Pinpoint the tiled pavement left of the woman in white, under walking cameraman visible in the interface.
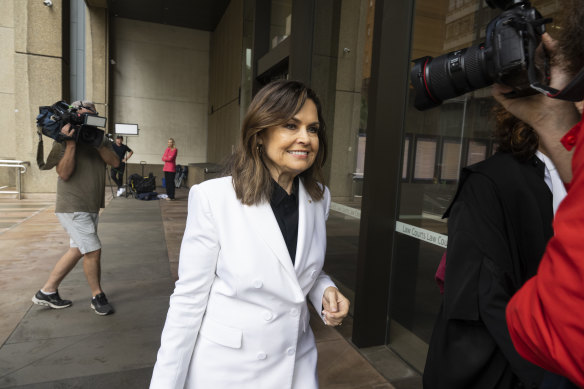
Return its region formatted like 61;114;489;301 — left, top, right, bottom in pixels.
0;192;172;389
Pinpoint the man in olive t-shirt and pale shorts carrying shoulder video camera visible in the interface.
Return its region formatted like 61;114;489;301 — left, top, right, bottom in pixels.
32;101;120;315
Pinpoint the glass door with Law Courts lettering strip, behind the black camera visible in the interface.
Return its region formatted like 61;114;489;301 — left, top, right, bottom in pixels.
387;0;559;371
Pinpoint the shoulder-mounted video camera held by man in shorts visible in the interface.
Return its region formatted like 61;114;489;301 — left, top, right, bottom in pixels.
36;101;107;147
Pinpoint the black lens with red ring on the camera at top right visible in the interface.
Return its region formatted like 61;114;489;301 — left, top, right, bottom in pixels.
411;45;494;111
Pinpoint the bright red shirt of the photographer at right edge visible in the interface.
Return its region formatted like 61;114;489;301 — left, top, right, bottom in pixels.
506;111;584;387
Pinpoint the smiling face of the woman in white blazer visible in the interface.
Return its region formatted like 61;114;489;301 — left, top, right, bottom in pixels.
260;99;319;182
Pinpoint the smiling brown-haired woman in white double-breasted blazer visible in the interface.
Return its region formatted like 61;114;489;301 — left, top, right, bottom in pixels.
150;80;349;389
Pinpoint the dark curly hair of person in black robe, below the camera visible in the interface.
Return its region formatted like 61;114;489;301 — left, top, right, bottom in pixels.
493;104;539;162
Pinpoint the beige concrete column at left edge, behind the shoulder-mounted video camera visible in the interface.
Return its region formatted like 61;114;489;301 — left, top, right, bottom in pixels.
9;0;69;193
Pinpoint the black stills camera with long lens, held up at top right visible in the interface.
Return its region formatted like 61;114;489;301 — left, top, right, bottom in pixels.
411;0;551;111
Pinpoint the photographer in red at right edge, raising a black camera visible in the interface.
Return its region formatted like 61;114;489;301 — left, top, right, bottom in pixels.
494;0;584;388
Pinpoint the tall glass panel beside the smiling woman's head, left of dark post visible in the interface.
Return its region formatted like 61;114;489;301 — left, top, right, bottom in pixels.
322;0;375;310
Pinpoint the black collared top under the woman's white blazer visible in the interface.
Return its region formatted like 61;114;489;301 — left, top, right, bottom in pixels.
270;177;298;263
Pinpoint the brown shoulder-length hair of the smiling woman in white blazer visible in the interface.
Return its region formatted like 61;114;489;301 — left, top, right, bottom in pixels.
225;80;327;205
